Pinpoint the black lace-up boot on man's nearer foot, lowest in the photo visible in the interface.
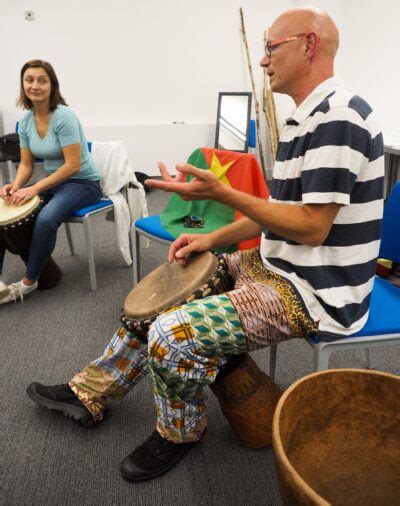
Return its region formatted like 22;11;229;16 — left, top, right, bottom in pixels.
120;430;200;481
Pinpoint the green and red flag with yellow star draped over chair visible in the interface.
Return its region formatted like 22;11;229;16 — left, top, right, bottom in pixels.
160;148;268;252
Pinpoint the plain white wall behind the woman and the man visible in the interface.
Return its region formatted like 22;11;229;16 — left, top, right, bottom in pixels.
0;0;400;173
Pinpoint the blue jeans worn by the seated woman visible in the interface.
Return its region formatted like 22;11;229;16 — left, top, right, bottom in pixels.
23;179;102;281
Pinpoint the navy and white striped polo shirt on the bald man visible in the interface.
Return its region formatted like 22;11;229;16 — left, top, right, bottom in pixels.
261;78;384;334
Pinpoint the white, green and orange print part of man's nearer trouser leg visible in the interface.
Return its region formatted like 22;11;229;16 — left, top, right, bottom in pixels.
149;295;246;443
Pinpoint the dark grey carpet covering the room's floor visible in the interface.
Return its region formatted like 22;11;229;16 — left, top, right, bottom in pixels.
0;191;400;506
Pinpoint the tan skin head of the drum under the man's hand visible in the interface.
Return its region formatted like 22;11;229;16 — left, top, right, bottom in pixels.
124;251;218;319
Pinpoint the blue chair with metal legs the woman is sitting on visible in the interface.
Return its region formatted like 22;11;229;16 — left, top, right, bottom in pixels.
64;141;114;292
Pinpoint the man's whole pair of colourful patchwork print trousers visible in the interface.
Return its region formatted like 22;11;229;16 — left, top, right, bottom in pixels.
69;250;315;443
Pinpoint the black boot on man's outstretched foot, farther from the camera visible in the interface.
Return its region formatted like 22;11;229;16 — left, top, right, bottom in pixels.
26;383;96;428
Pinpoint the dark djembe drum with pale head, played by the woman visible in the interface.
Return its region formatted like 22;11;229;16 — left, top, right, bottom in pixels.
0;196;63;290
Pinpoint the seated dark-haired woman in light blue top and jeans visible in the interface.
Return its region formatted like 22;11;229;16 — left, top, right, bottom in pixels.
0;60;101;304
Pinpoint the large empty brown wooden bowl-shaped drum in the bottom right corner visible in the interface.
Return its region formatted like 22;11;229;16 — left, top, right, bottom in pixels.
273;369;400;506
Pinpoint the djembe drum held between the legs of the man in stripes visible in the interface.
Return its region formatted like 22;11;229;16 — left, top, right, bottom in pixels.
121;252;281;448
